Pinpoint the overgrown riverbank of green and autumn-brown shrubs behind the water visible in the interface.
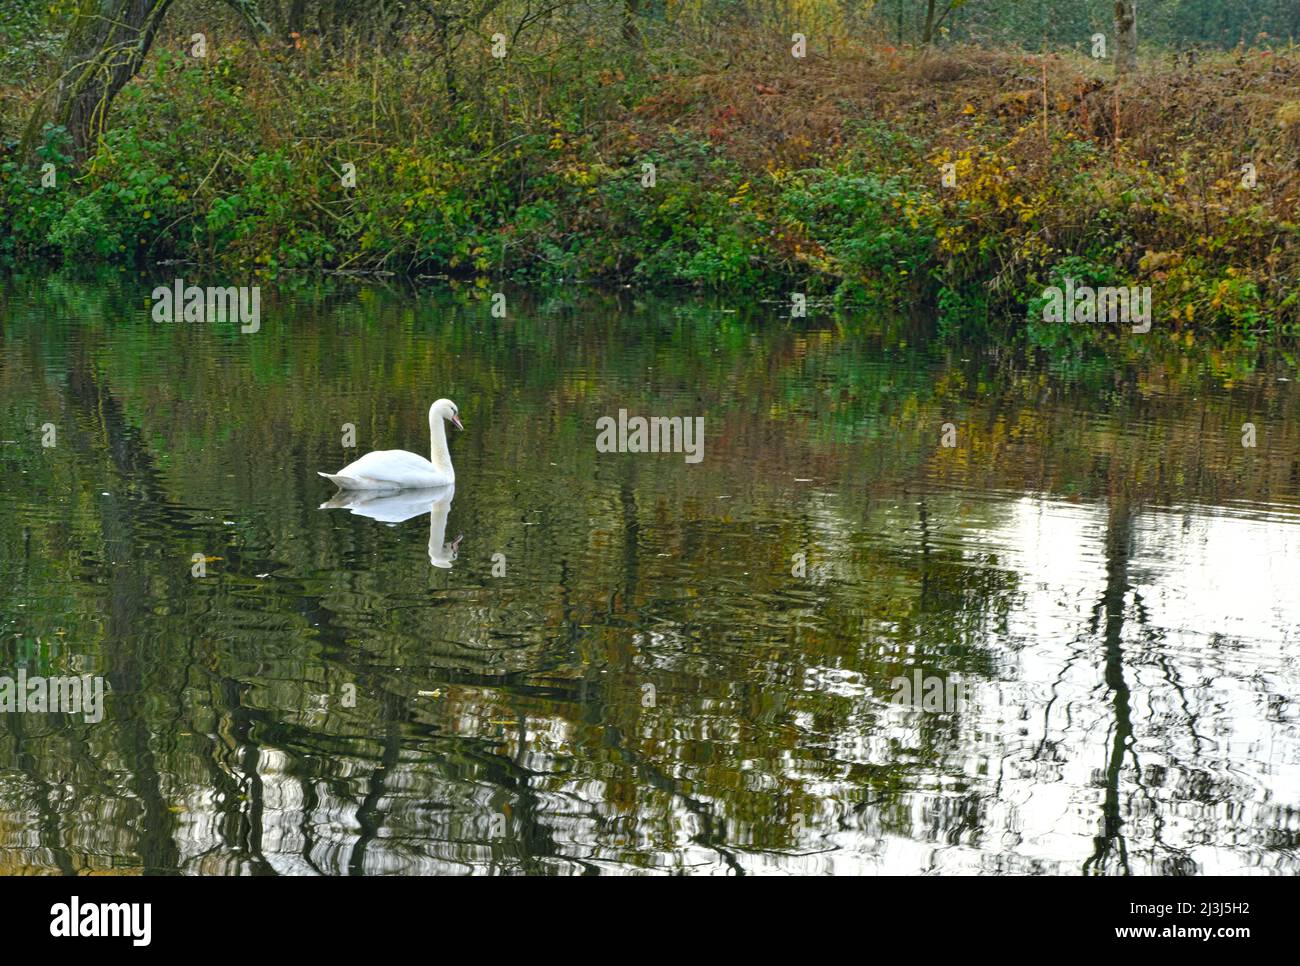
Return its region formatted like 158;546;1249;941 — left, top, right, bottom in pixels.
0;23;1300;341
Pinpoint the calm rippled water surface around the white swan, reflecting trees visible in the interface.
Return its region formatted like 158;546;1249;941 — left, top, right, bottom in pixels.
0;278;1300;875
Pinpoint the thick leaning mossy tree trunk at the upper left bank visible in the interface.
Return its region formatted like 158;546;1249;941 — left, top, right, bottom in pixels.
55;0;173;160
